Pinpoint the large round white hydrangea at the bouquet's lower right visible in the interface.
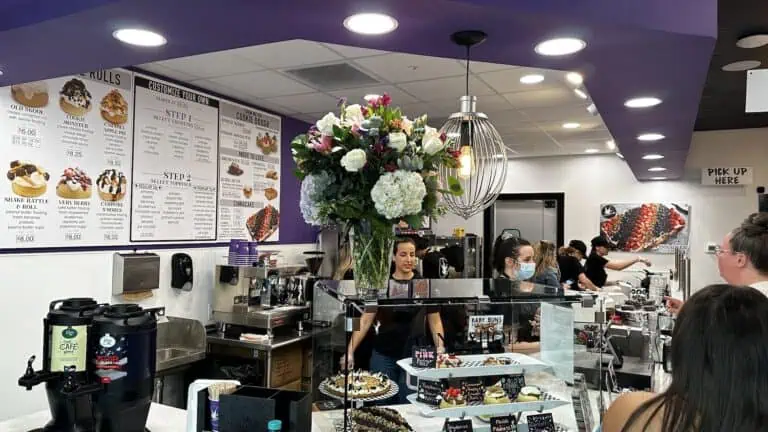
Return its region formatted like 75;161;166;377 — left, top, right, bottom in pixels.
371;170;427;219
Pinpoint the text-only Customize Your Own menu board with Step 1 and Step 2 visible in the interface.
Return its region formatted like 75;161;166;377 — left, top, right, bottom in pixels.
131;75;219;242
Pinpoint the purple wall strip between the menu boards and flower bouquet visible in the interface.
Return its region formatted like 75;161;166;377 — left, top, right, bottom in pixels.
278;116;317;244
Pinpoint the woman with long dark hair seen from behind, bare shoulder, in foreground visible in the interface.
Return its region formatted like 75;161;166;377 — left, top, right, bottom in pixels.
603;285;768;432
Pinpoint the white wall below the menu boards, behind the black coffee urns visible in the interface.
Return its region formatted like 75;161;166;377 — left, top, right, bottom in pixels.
0;245;314;421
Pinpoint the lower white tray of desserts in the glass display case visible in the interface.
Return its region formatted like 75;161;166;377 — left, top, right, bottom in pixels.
408;393;570;418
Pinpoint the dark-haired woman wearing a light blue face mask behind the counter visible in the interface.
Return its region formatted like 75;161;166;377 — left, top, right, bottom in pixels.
493;237;541;352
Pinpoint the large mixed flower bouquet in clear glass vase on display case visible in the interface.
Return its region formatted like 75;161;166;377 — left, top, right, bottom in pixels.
291;94;462;289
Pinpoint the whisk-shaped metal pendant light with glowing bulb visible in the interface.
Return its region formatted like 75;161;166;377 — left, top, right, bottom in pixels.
440;30;507;219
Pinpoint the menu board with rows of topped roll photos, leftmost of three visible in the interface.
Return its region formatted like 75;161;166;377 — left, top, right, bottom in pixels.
0;69;133;249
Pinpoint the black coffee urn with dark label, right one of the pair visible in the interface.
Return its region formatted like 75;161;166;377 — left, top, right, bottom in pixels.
90;304;165;432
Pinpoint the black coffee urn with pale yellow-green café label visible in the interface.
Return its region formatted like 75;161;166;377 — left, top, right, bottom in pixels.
19;298;104;432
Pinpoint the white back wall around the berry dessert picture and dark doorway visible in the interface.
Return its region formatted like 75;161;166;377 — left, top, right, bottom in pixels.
435;128;768;290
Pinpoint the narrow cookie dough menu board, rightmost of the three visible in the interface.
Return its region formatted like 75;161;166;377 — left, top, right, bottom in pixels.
218;101;281;242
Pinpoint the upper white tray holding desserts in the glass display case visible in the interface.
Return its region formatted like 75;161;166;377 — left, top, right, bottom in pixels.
397;353;551;380
